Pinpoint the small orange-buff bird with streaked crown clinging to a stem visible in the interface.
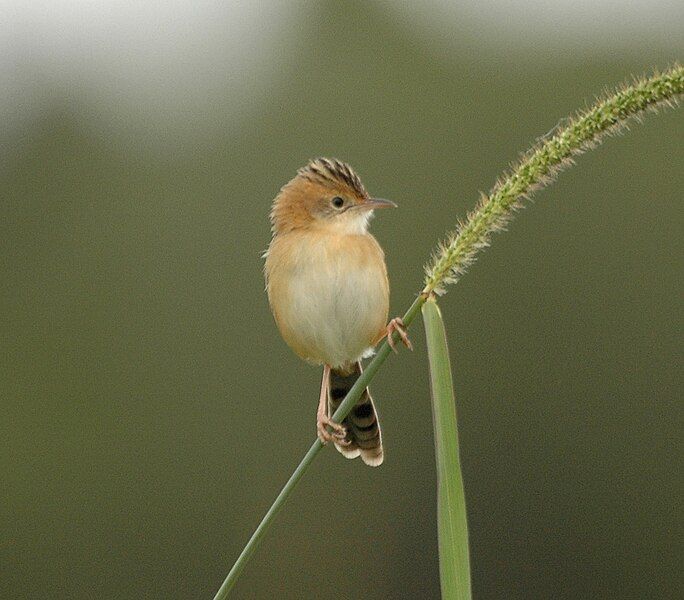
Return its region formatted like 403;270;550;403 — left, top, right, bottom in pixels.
264;158;412;467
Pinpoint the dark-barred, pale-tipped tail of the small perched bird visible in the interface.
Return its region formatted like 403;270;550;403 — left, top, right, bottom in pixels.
328;362;383;467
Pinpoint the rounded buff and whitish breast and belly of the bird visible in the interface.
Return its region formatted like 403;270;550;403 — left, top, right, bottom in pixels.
267;235;388;367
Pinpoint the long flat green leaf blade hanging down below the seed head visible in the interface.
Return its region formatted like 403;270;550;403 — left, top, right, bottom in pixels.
422;297;471;600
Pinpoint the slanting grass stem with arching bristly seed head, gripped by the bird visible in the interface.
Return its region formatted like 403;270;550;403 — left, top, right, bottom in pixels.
214;65;684;600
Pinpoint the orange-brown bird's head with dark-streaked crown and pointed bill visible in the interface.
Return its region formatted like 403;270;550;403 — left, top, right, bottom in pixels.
271;158;396;234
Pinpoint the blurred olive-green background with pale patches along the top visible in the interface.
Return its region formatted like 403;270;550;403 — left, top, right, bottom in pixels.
0;0;684;600
